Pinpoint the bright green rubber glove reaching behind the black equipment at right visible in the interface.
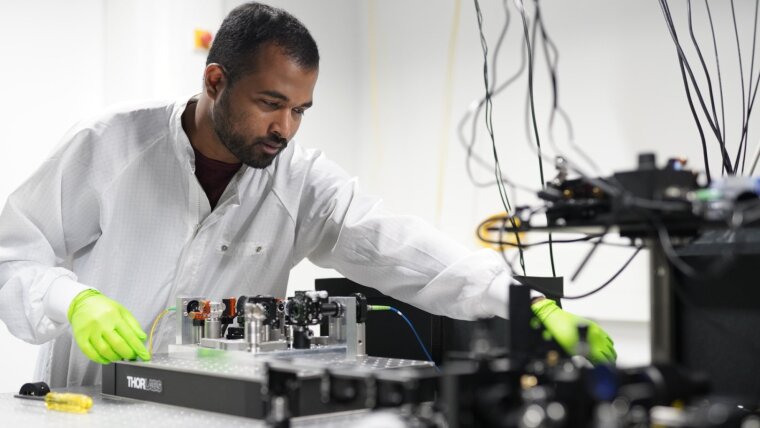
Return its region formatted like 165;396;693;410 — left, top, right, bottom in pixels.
530;299;617;364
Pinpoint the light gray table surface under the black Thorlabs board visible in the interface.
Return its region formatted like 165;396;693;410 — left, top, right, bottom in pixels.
0;386;393;428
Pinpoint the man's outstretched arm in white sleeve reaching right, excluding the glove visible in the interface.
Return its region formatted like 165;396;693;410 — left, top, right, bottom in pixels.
296;150;510;319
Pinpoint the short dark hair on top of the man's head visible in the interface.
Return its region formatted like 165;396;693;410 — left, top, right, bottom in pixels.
206;2;319;84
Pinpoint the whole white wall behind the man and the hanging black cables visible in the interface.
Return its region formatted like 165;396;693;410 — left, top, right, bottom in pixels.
0;0;751;391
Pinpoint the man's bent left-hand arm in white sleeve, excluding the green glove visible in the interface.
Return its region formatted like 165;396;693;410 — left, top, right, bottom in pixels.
0;128;100;343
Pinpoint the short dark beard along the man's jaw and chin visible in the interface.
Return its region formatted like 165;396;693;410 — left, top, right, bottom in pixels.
211;91;288;169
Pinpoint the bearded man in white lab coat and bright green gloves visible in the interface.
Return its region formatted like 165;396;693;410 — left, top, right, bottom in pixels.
0;3;615;387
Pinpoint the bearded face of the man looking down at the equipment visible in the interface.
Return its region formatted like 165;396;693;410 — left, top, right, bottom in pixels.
211;44;318;168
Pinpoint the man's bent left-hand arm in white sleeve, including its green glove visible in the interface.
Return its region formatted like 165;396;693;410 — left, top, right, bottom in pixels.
0;130;150;364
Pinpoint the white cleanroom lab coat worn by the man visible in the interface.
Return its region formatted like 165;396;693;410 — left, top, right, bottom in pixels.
0;101;509;387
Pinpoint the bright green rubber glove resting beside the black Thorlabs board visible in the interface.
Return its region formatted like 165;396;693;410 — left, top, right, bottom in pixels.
68;290;150;364
